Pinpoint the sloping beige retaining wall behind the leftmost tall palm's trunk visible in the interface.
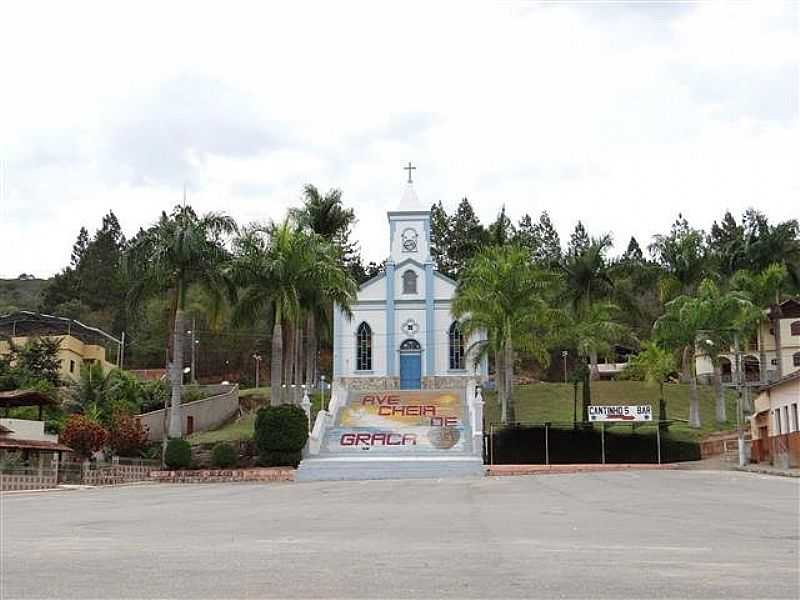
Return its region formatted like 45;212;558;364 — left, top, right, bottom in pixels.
136;385;239;442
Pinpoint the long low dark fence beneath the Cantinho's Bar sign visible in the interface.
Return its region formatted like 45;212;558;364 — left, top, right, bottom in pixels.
484;421;700;465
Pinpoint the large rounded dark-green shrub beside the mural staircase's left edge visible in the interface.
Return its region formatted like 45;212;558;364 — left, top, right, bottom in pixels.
255;404;308;467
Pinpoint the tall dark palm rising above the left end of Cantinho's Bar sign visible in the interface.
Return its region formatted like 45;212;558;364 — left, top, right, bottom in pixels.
561;235;614;379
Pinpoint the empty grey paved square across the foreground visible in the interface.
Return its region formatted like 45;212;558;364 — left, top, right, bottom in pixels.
0;471;800;599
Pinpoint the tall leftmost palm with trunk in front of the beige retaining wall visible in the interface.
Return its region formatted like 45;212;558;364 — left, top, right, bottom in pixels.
125;205;237;438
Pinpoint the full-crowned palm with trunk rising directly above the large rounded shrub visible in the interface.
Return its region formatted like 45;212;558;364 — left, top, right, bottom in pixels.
232;219;356;405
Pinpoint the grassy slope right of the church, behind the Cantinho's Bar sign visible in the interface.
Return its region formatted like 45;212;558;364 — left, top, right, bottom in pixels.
484;381;736;440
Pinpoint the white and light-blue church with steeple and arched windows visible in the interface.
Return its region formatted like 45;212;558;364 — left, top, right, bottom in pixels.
333;182;487;390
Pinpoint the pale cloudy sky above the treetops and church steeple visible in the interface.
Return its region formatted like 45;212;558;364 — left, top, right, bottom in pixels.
0;0;800;278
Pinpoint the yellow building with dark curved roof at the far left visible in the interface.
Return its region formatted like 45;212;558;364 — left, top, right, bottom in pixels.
0;311;122;381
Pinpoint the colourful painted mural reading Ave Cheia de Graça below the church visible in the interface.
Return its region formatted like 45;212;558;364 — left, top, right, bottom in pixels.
326;390;466;454
